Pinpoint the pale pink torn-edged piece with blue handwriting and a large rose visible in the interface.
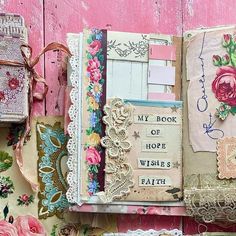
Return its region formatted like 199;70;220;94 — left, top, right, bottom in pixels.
186;28;236;152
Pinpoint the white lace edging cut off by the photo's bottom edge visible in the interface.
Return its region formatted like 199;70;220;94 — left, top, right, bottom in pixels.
104;229;183;236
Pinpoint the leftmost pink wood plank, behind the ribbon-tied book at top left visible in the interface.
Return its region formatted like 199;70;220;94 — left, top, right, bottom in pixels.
0;0;45;115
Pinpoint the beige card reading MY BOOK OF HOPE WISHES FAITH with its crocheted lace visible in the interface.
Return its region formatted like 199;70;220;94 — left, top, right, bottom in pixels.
99;99;182;201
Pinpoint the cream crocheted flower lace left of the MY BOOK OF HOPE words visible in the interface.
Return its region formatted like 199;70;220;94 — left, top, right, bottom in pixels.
97;98;134;203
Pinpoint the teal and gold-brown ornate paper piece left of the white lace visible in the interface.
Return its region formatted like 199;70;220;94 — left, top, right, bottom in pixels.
36;122;69;219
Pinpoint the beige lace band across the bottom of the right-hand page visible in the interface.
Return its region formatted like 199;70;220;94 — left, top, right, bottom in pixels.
184;174;236;223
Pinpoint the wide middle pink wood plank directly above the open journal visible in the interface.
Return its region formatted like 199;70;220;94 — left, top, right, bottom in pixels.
45;0;182;115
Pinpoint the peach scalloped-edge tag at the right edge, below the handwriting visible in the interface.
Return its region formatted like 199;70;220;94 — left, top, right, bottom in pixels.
217;137;236;179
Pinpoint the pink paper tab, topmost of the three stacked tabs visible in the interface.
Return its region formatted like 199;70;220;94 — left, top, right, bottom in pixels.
149;45;176;61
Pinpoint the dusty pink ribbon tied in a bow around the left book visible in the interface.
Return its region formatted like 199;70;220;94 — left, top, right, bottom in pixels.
0;42;71;191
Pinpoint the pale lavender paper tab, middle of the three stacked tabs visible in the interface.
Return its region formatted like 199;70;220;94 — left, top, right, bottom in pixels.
148;65;175;85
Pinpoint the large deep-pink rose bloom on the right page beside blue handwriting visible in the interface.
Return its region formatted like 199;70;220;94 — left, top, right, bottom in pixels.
212;66;236;106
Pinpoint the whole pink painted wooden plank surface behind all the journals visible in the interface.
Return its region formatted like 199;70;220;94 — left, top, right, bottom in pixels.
0;0;236;234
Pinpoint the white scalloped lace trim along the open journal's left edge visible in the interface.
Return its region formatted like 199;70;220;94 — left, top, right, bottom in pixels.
66;34;82;204
